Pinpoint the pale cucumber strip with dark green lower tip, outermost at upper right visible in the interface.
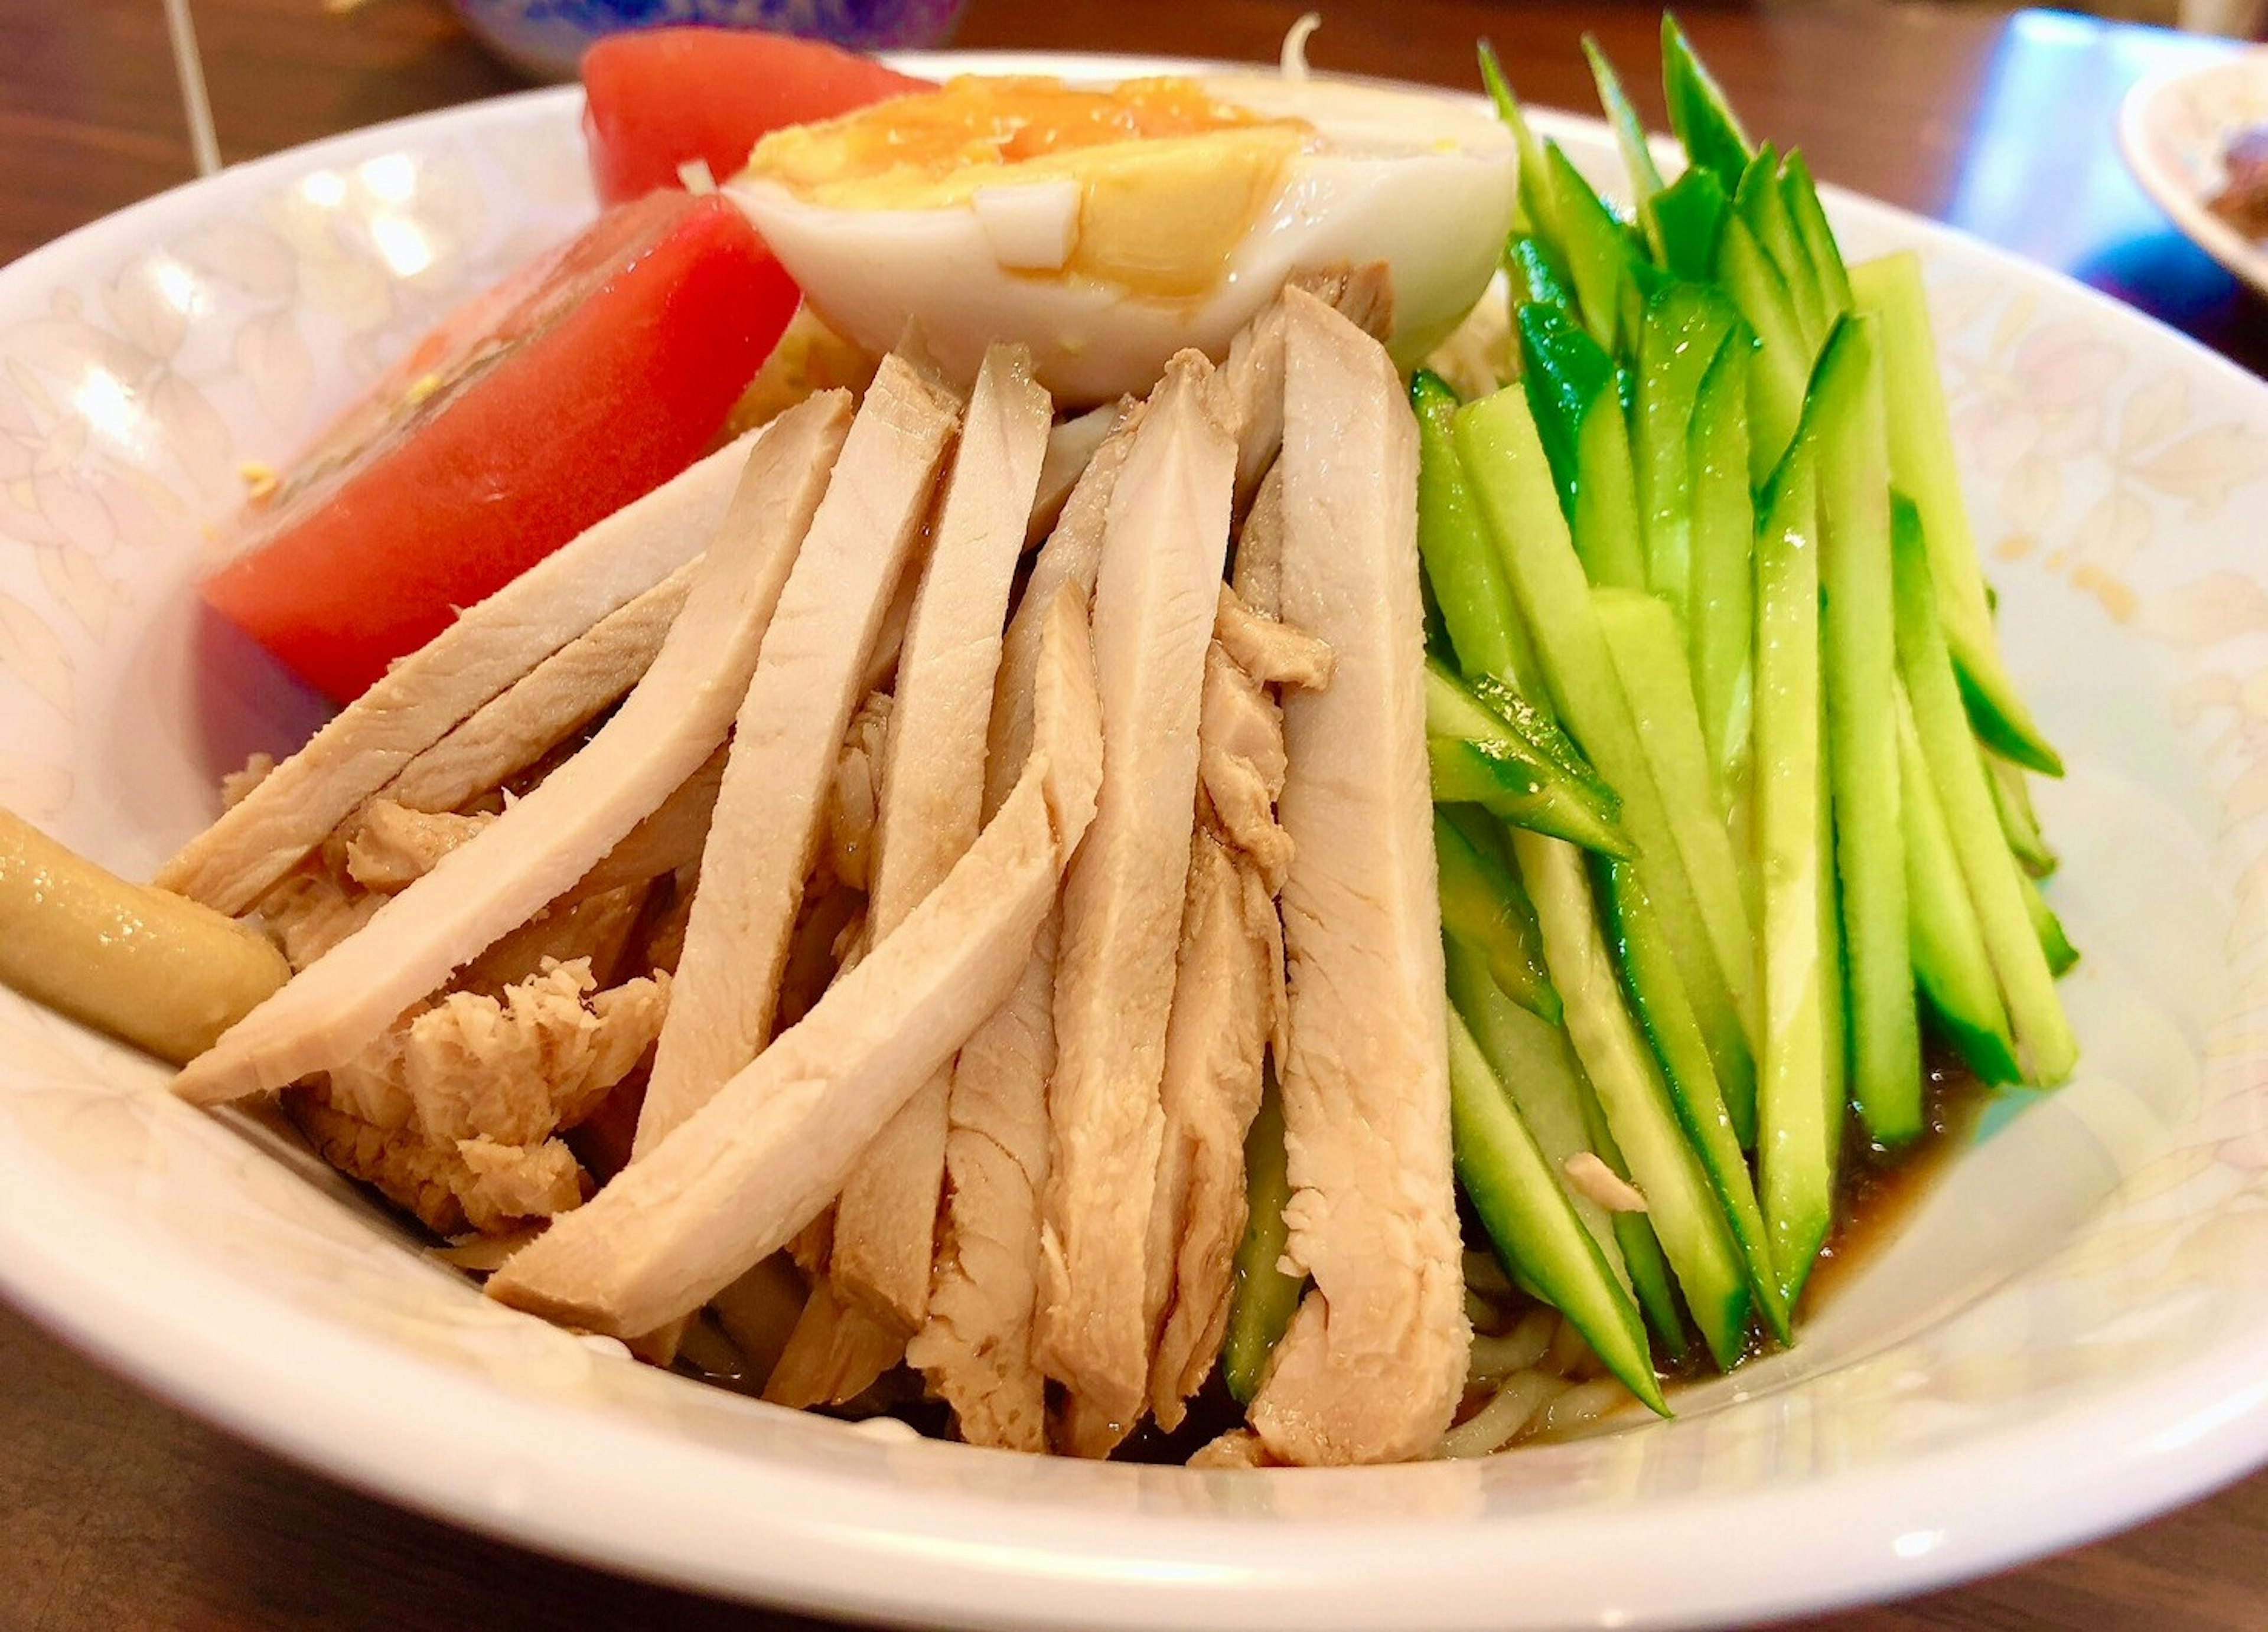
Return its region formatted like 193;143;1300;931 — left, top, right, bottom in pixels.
1850;252;2064;775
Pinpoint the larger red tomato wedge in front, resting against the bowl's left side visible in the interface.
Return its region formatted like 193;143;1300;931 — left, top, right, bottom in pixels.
204;192;796;703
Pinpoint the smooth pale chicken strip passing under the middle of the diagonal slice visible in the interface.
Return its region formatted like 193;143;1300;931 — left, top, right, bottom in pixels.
832;347;1052;1341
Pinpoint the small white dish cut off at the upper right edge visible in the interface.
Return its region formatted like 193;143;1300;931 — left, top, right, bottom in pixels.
2119;50;2268;295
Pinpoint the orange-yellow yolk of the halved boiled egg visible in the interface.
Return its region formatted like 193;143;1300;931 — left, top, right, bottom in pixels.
746;75;1315;297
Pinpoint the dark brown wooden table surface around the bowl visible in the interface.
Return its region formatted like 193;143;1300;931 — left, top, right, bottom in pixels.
0;0;2268;1632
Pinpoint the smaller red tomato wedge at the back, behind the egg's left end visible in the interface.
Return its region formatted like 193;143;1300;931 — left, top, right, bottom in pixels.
583;27;932;204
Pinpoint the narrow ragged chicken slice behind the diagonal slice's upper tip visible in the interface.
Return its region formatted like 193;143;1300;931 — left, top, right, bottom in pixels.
907;410;1139;1451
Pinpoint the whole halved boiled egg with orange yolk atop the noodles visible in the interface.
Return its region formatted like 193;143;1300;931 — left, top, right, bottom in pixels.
728;73;1515;401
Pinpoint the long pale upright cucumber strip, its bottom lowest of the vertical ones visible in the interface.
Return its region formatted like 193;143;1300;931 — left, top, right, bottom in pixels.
1755;444;1842;1308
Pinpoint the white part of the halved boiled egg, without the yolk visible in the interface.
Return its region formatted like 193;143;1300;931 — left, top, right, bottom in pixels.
726;73;1515;403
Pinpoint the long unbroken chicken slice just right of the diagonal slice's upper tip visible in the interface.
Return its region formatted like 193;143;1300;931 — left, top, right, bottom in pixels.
1034;351;1236;1455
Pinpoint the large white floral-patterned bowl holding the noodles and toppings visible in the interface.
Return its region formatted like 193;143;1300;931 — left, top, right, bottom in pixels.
0;59;2268;1627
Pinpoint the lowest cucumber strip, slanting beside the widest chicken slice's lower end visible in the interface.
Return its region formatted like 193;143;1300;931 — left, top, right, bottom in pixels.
1449;1011;1669;1416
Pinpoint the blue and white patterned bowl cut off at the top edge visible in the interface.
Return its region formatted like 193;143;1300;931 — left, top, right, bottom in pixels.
456;0;964;79
